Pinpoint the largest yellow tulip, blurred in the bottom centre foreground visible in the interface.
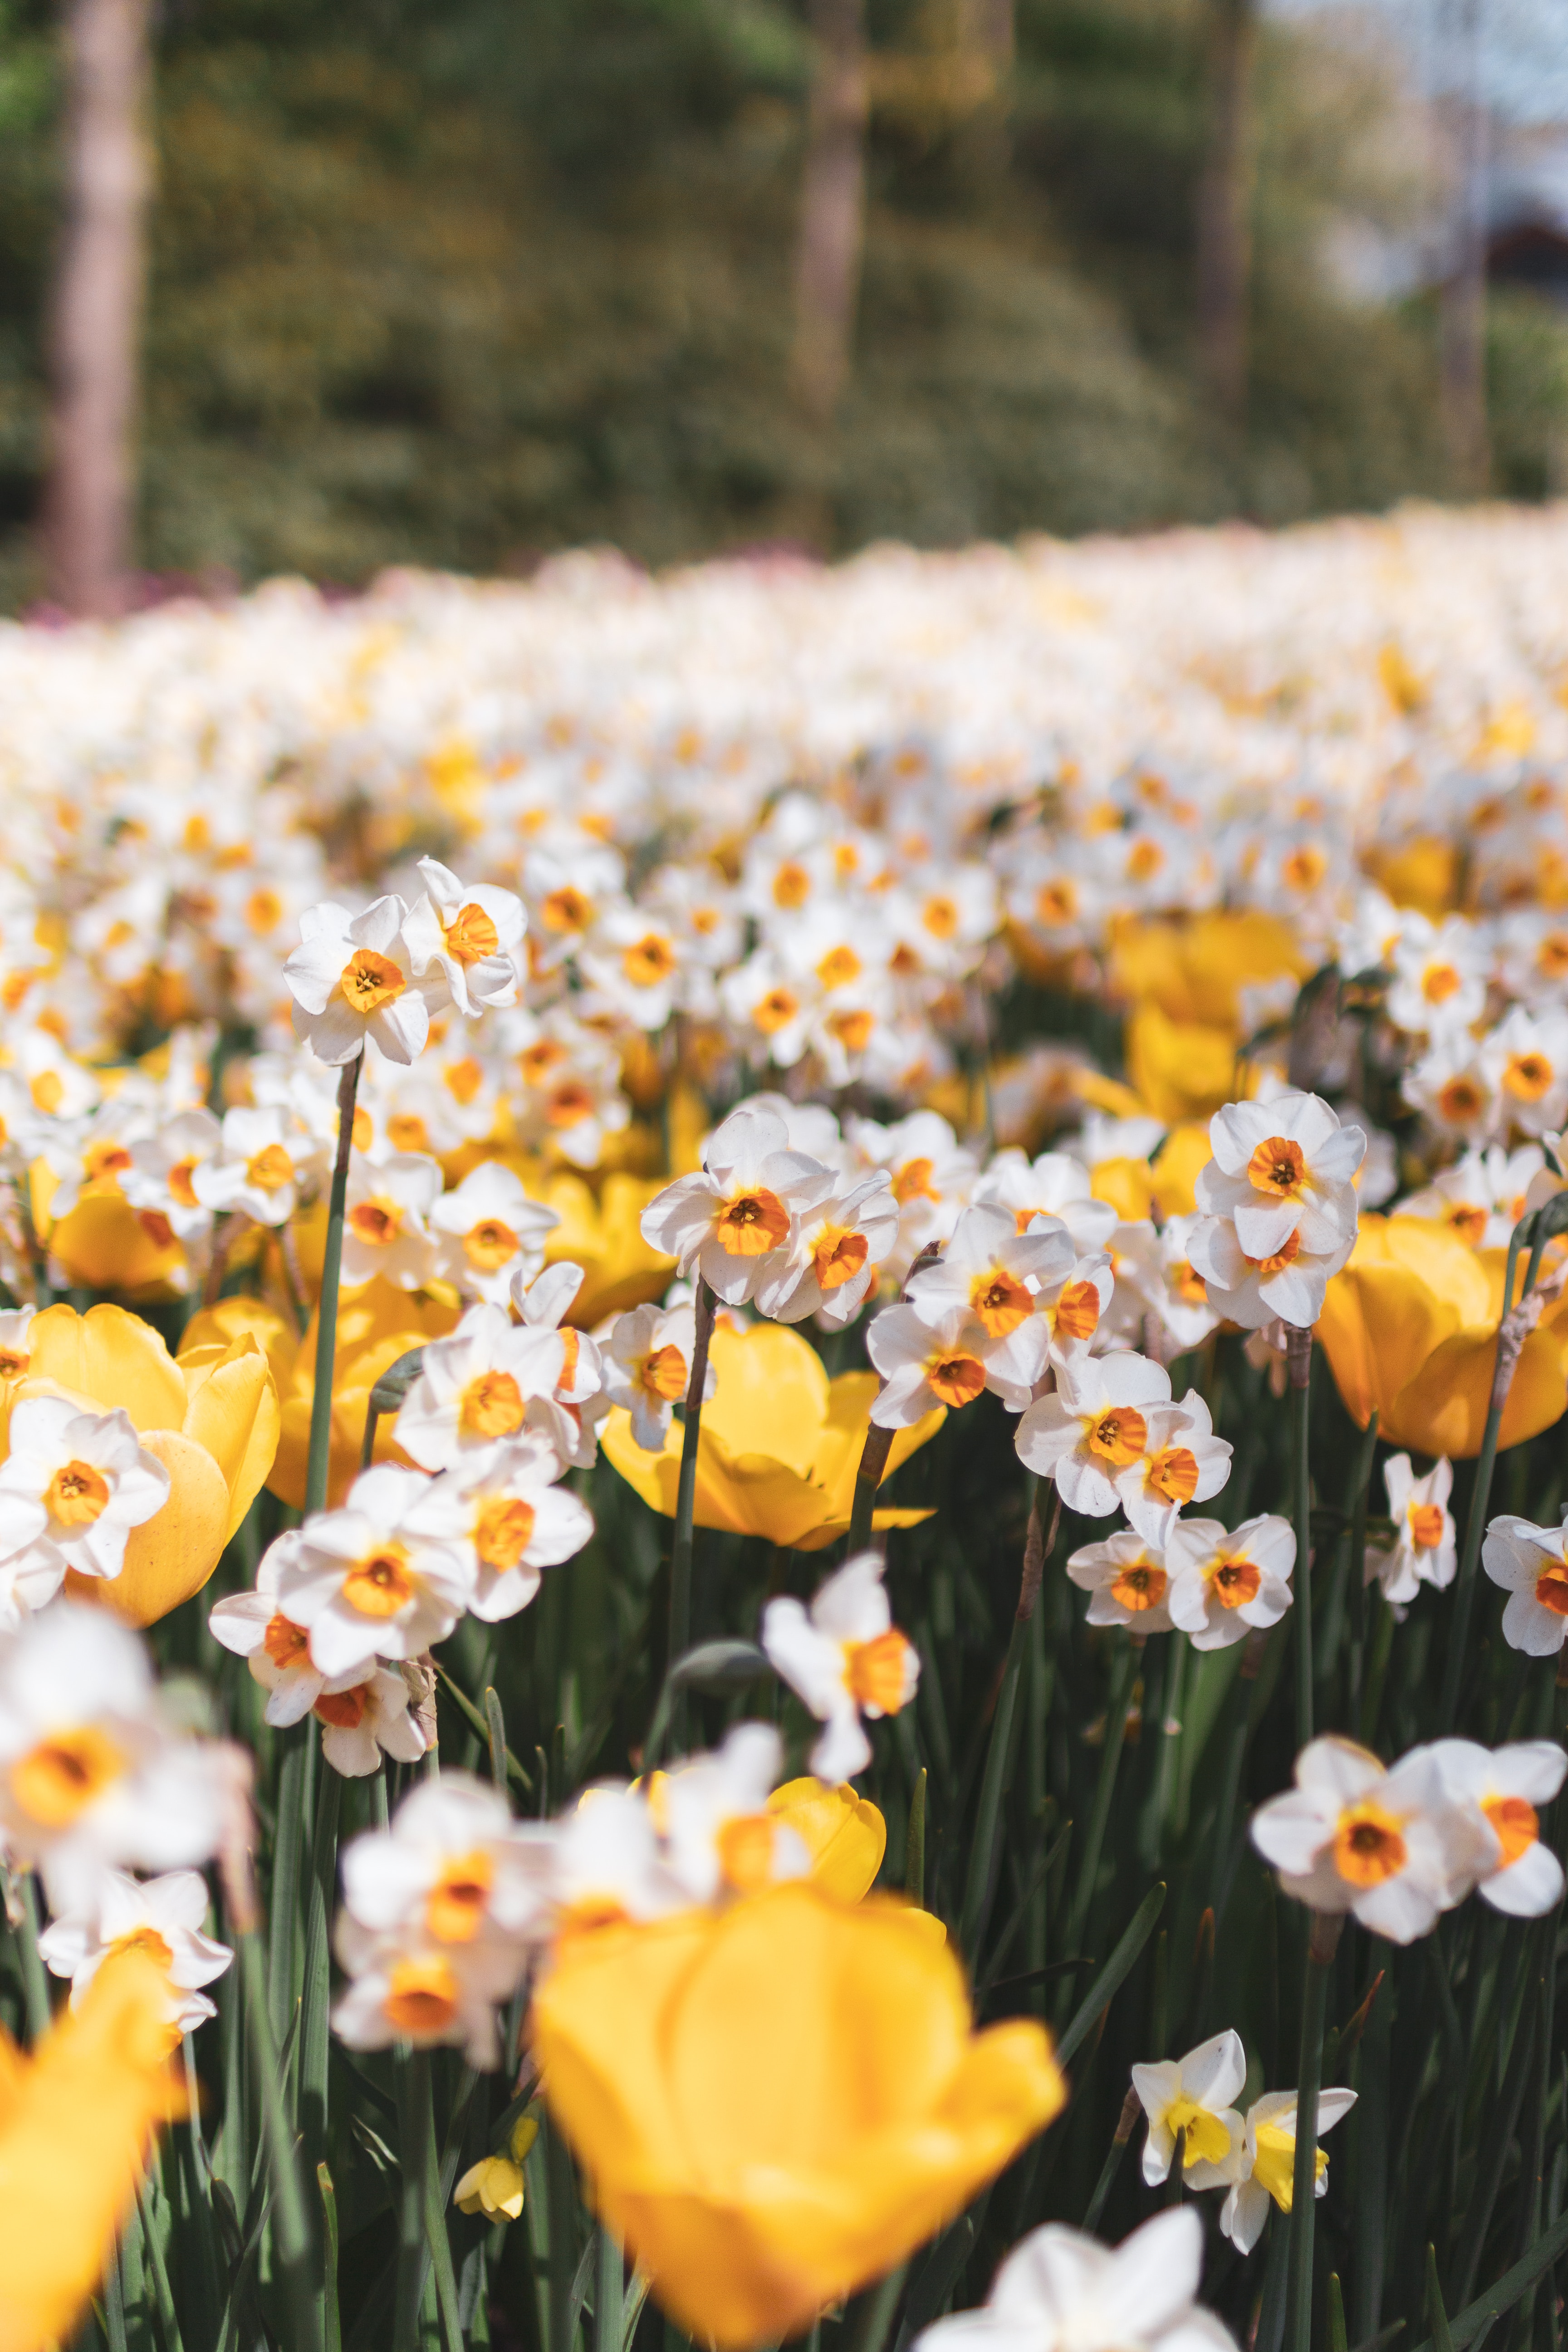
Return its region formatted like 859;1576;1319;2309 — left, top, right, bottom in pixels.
534;1882;1065;2352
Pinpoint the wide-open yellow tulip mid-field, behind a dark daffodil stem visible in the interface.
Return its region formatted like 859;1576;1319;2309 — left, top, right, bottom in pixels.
599;1322;947;1552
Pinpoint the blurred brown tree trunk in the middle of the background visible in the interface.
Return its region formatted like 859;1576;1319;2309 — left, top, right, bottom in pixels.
792;0;870;426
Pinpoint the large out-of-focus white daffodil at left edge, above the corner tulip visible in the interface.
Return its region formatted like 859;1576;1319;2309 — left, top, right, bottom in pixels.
0;1602;223;1912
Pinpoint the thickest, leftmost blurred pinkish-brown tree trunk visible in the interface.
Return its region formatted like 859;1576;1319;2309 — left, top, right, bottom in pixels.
44;0;151;614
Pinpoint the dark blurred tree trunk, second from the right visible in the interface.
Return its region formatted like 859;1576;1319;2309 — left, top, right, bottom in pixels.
1199;0;1258;431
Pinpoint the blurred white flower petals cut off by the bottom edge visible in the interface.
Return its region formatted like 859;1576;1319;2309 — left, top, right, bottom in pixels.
915;2206;1236;2352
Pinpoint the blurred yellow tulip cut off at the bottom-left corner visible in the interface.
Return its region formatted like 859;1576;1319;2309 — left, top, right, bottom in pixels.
0;1952;183;2352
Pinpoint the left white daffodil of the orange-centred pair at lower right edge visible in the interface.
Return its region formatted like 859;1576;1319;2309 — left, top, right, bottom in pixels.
1253;1738;1495;1943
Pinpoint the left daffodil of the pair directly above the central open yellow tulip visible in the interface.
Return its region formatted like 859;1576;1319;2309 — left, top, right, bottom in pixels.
642;1103;834;1305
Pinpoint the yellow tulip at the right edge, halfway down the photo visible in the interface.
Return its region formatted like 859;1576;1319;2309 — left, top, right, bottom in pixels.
1317;1216;1568;1460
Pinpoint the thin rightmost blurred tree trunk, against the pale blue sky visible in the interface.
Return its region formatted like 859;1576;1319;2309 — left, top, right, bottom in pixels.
1439;0;1490;496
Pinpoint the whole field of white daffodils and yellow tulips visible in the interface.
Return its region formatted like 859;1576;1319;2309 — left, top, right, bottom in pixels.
0;510;1568;2352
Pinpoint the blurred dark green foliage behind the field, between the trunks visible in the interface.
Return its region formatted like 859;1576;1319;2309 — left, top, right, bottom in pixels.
0;0;1563;602
